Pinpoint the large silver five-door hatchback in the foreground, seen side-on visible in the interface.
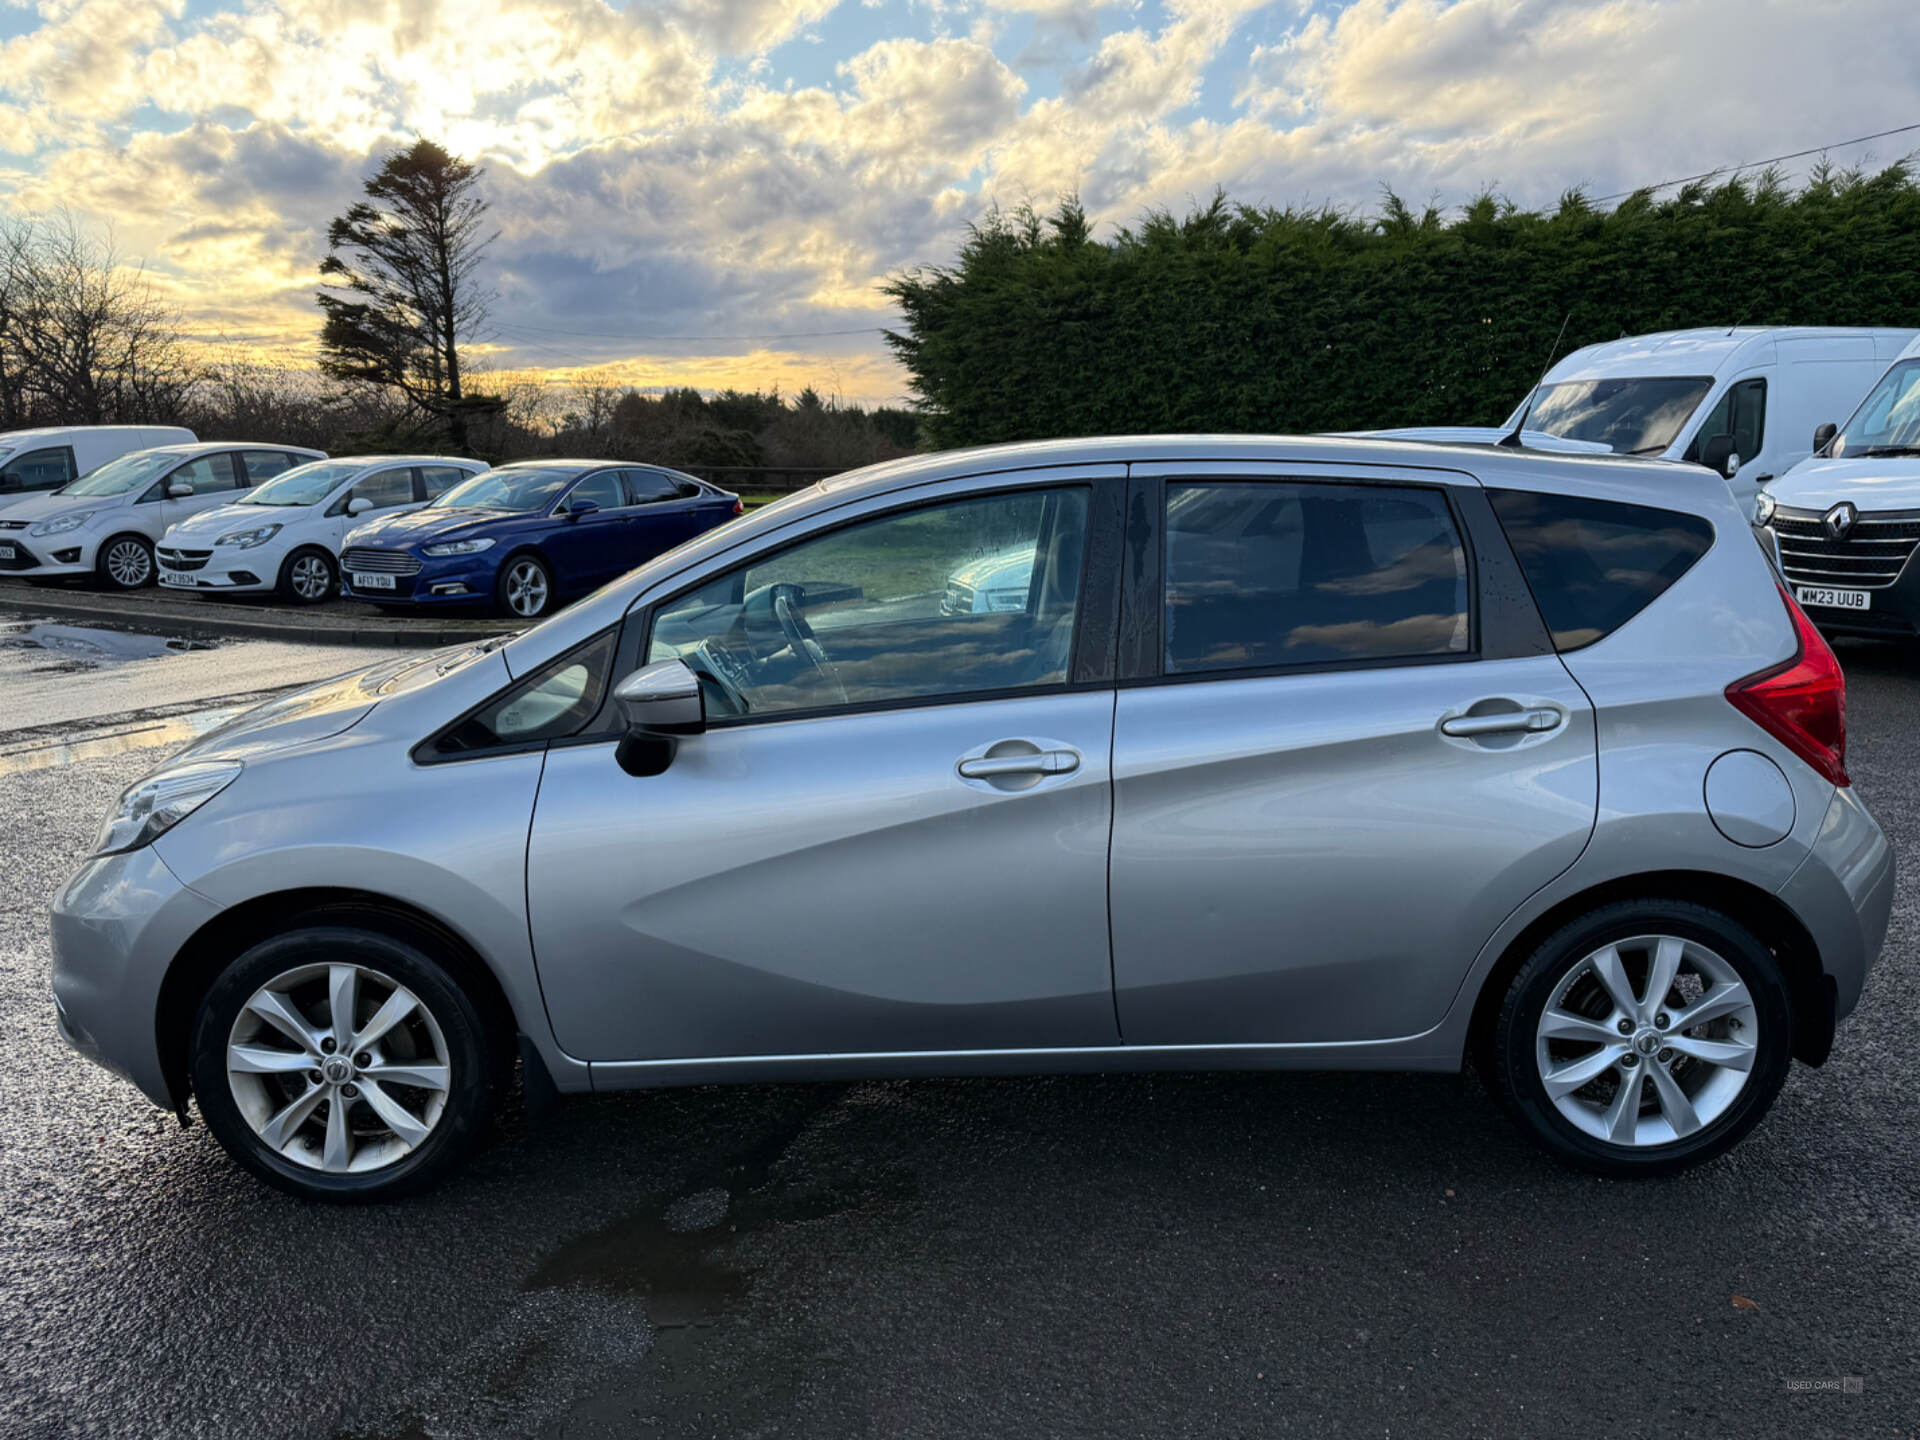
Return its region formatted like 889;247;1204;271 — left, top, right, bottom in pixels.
54;436;1893;1200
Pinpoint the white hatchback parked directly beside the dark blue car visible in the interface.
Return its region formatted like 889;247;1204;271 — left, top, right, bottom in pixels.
159;455;488;605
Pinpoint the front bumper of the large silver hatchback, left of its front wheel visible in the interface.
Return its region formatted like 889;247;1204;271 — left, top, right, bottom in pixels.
52;845;219;1110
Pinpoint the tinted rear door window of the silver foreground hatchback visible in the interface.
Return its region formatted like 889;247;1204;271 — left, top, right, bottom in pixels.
1165;480;1473;674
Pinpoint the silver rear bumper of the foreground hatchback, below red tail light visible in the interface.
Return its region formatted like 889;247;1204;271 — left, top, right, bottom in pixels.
1780;787;1893;1023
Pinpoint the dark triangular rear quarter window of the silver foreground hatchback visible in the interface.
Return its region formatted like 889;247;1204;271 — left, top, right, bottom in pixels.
1486;490;1713;651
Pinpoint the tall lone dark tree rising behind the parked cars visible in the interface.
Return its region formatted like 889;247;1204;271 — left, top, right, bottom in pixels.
317;140;497;449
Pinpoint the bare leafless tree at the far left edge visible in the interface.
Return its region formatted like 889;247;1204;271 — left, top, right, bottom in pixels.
0;213;194;426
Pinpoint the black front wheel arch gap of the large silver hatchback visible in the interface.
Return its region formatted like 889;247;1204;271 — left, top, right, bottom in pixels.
154;887;522;1112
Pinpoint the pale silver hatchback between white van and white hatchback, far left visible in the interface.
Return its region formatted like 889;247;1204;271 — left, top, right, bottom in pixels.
0;442;326;589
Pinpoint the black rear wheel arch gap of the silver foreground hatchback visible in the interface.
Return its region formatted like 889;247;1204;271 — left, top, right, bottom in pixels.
1467;870;1836;1073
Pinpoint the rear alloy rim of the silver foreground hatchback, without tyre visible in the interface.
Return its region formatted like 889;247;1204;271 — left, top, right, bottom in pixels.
1534;935;1759;1148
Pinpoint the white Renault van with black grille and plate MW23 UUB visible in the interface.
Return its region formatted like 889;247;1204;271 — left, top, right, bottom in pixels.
1757;340;1920;639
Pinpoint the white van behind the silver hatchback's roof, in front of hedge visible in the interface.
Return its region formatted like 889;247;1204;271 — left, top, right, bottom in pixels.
1373;326;1920;515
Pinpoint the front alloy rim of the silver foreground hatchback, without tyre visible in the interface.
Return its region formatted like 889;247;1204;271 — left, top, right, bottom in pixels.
227;964;453;1175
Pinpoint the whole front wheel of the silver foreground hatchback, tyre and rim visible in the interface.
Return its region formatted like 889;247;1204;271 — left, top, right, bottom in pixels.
190;914;507;1202
